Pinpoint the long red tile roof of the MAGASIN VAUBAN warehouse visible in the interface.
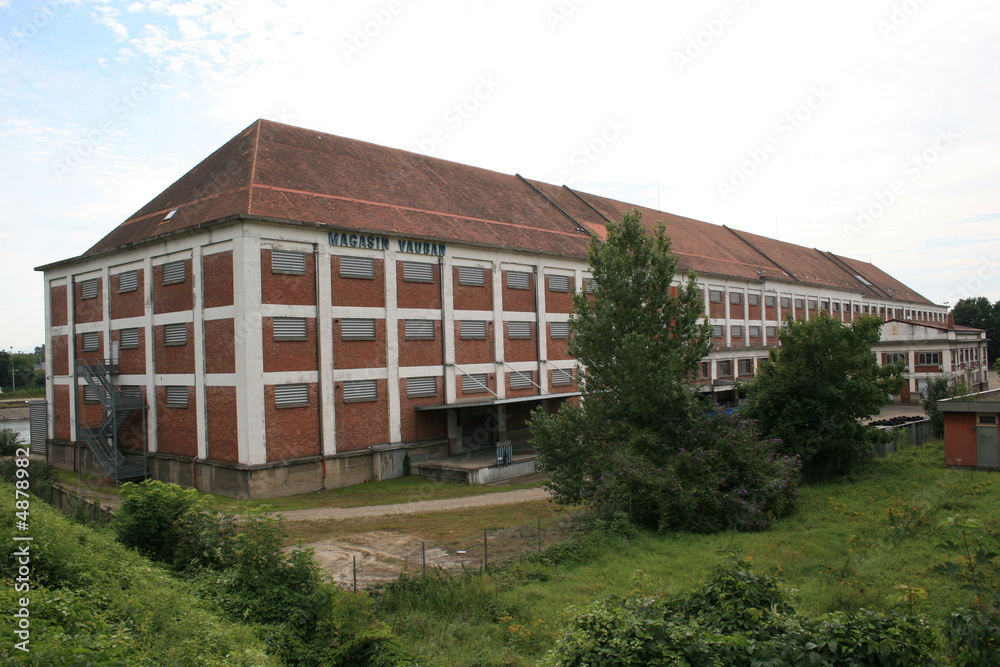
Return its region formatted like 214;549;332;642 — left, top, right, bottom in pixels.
68;120;930;304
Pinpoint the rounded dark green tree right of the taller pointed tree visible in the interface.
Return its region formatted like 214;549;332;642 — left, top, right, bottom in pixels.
744;312;903;479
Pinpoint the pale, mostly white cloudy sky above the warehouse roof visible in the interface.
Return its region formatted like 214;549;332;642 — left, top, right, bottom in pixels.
0;0;1000;349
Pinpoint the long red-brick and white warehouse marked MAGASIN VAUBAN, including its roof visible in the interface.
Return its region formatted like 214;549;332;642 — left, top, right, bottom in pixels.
33;120;986;497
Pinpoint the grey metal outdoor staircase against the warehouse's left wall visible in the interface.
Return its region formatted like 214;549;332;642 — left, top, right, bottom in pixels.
76;359;148;481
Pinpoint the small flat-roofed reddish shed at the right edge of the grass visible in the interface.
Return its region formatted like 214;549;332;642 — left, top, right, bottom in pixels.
937;389;1000;468
